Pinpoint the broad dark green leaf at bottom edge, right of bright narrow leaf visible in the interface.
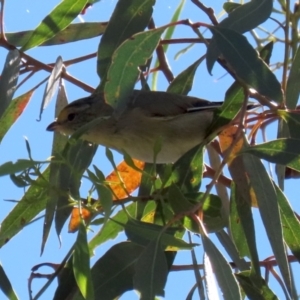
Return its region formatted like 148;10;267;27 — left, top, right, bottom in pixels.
92;242;144;300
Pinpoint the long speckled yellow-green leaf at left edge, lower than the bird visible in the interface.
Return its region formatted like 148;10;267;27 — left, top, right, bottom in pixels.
0;167;49;247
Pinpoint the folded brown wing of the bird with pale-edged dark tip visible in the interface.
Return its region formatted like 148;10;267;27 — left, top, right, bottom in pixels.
129;90;222;117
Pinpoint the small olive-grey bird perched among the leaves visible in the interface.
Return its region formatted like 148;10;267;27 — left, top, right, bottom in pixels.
47;90;223;163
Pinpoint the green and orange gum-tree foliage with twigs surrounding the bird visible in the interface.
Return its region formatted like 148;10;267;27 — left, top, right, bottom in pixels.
0;0;300;300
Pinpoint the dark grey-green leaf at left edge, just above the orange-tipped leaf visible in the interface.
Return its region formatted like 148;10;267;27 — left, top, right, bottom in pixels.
0;50;21;118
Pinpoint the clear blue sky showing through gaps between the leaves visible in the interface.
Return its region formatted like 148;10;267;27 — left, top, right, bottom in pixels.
0;0;299;299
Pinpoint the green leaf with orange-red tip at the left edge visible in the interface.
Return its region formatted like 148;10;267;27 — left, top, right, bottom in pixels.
0;90;33;142
